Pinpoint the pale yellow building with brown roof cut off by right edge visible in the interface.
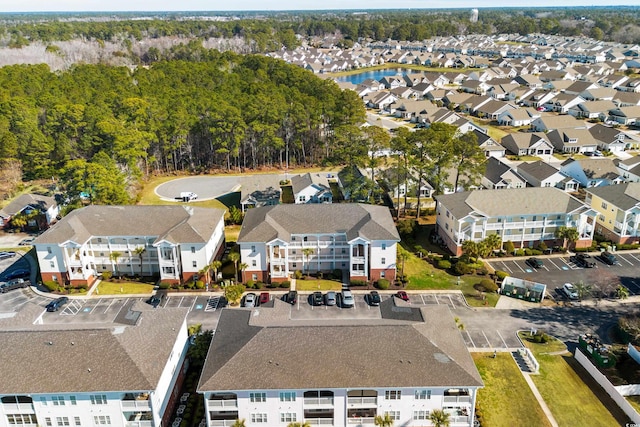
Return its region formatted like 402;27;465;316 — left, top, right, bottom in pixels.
585;182;640;244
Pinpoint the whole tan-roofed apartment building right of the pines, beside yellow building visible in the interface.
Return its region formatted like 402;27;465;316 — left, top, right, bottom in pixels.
435;187;596;255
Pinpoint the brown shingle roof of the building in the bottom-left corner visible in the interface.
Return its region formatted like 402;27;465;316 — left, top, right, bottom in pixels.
0;303;187;394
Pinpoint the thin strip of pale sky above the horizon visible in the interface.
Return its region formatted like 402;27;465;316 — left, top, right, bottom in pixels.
0;0;638;12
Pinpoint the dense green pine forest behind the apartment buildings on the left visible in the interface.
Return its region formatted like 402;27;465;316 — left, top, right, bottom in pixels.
0;53;366;203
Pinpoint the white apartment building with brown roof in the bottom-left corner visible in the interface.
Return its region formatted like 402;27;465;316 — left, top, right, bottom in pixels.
0;303;188;427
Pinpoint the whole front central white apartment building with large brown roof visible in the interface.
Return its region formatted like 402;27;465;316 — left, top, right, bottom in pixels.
197;304;483;427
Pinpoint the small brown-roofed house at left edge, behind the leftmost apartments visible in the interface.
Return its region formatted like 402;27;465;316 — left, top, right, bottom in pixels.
0;194;59;230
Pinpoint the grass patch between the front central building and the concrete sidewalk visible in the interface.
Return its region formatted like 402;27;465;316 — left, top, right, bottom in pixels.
471;353;551;427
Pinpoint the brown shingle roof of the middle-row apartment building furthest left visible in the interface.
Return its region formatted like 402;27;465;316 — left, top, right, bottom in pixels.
34;205;225;244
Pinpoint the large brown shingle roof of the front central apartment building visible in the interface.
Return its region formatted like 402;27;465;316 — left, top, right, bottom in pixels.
198;306;483;392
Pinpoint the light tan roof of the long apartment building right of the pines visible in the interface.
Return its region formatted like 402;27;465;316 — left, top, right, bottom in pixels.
435;187;584;218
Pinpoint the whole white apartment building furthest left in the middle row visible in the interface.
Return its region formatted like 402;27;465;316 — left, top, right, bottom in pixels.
34;205;224;285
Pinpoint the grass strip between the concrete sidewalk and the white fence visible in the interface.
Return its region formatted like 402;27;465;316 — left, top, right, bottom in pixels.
523;334;619;427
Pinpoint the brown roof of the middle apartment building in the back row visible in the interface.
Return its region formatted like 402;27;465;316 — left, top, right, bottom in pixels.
238;203;400;243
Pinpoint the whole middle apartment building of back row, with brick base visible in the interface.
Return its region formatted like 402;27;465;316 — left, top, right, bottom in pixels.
238;203;400;282
